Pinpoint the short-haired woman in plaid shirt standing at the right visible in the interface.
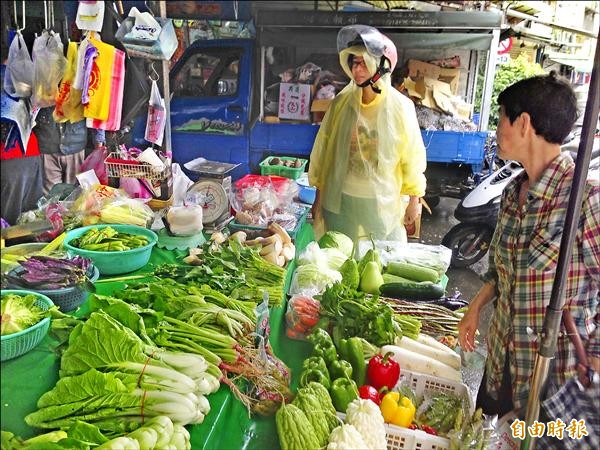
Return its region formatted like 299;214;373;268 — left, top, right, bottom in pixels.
458;73;600;415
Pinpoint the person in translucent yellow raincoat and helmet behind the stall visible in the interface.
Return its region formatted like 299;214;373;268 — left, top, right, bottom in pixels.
308;25;426;242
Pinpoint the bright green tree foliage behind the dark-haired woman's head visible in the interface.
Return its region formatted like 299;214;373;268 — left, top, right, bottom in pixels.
475;54;546;130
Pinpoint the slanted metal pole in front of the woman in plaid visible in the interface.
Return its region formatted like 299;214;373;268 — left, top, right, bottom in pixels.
521;31;600;450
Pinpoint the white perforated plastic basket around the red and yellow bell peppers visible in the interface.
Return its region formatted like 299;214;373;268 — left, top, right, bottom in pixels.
337;370;475;450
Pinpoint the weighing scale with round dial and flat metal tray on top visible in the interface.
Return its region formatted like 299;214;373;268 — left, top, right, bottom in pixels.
185;158;240;233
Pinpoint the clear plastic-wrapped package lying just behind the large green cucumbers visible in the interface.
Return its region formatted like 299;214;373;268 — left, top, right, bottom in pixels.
358;239;452;276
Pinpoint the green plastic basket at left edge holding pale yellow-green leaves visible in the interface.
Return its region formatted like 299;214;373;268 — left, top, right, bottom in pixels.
0;289;54;361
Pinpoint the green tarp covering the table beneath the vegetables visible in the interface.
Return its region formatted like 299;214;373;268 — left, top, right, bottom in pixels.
0;224;314;450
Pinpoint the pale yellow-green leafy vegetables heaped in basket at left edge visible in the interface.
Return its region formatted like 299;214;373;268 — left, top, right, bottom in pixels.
0;294;50;336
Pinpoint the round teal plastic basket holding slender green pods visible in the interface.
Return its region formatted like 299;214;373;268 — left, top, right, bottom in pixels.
63;224;158;275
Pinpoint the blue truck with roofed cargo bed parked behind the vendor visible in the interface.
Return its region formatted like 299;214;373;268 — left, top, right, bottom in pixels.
135;7;500;196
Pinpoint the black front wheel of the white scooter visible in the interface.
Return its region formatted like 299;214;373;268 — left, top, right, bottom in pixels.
442;223;494;267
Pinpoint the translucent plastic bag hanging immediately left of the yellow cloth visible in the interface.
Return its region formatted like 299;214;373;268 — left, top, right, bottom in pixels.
31;31;67;108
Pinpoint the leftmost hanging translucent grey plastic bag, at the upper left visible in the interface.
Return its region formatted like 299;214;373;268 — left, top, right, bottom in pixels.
4;32;33;98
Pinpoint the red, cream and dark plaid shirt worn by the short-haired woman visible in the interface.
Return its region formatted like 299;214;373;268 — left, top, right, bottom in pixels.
485;154;600;408
